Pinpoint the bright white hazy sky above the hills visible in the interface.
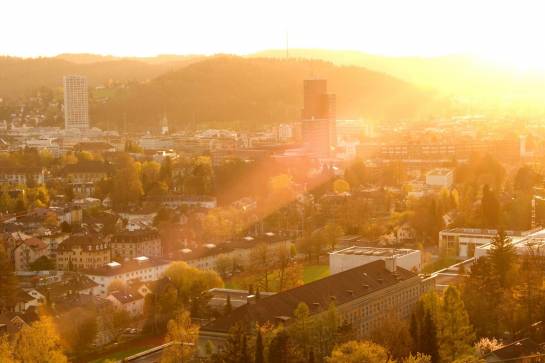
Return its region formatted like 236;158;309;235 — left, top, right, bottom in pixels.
4;0;545;63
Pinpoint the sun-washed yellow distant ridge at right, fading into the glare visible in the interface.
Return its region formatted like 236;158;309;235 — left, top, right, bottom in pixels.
251;49;545;101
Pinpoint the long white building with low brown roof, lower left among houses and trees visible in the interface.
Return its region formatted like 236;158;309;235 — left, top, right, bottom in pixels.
83;256;170;297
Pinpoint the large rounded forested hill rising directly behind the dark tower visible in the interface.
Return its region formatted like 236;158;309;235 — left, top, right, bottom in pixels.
92;56;437;129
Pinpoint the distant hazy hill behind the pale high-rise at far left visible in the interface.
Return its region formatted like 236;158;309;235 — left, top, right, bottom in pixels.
0;55;201;98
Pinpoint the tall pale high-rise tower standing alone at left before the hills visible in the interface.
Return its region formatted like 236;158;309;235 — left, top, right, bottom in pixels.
64;76;89;129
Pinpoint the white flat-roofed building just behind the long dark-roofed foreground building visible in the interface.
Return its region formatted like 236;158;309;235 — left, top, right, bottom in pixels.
329;246;422;274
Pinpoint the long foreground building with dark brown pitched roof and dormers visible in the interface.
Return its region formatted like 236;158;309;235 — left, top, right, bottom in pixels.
199;260;435;349
